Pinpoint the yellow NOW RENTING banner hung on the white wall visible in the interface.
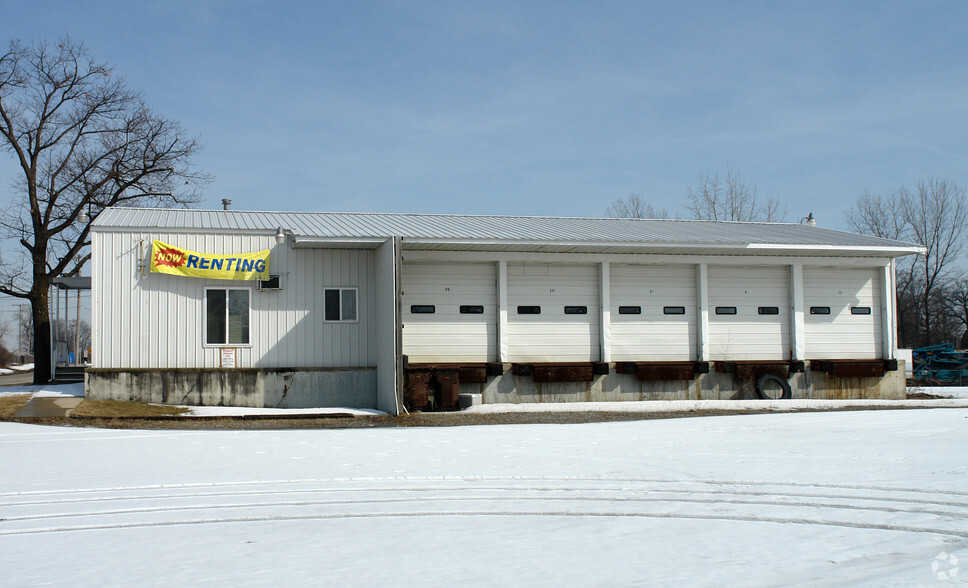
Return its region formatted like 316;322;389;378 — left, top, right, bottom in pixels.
151;241;269;280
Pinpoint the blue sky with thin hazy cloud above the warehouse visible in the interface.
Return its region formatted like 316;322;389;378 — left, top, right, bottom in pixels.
0;0;968;229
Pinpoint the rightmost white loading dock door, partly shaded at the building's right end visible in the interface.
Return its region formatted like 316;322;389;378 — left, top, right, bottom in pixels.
803;267;883;359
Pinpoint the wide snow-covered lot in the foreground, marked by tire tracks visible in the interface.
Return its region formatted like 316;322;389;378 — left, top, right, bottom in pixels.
0;408;968;586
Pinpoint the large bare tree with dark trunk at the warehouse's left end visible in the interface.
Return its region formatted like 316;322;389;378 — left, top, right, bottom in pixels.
0;37;209;383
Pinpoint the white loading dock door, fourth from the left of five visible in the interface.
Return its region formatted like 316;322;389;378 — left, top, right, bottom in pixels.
708;266;790;361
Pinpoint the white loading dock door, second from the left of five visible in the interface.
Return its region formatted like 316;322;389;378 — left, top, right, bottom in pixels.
508;263;601;362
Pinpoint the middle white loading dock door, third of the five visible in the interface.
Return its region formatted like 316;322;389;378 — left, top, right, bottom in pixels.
609;264;698;361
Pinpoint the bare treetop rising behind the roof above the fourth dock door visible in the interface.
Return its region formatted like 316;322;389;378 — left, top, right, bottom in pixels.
685;168;786;222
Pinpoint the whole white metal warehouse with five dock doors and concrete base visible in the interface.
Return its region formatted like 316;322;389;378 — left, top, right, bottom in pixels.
86;208;920;414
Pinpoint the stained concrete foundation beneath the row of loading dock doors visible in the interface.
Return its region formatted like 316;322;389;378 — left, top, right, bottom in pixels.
460;362;905;404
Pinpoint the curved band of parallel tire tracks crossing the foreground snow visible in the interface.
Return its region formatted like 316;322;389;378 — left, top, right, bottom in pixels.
0;476;968;538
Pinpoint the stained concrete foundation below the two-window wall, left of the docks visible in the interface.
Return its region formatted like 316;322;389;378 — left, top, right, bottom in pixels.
84;367;377;408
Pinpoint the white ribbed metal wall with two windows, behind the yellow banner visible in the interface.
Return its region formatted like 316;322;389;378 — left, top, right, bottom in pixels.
92;232;375;368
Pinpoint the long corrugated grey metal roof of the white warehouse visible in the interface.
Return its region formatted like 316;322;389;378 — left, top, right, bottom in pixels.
95;208;915;254
